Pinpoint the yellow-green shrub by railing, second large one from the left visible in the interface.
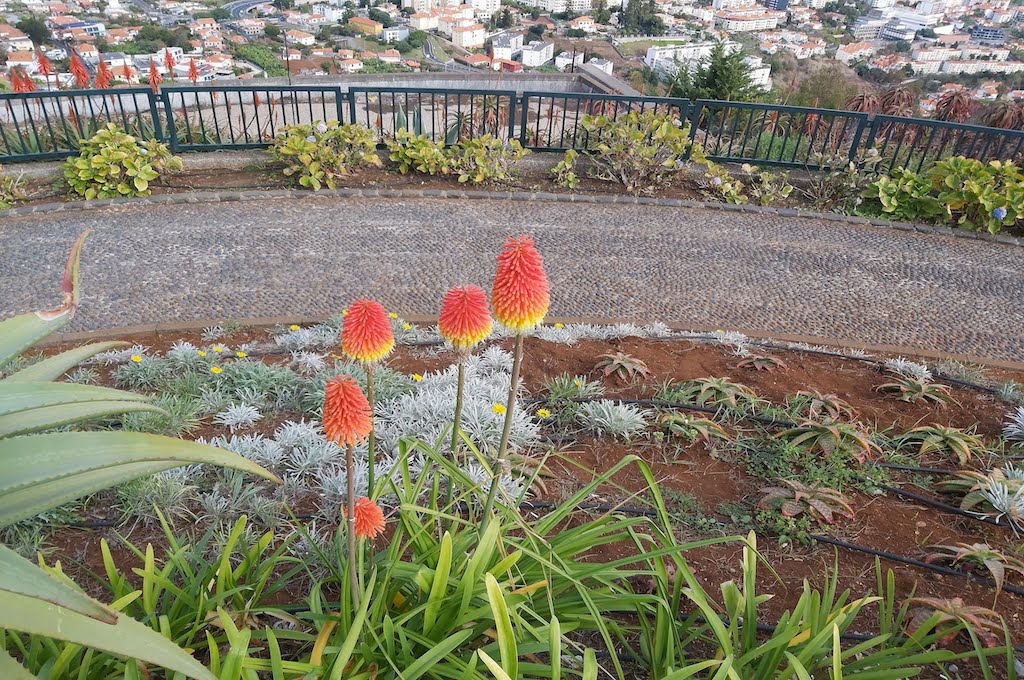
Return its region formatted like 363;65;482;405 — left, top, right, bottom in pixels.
267;121;381;192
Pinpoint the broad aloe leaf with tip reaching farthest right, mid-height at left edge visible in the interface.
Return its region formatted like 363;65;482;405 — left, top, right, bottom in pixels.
0;432;279;526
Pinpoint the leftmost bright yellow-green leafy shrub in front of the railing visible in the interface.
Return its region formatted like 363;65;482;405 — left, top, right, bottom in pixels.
63;123;181;201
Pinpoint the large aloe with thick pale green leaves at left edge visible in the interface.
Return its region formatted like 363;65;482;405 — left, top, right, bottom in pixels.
0;231;278;680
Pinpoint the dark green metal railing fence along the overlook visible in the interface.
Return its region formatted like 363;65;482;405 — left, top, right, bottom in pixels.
0;84;1024;172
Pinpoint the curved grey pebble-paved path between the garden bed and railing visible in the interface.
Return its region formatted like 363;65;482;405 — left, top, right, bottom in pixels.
0;197;1024;362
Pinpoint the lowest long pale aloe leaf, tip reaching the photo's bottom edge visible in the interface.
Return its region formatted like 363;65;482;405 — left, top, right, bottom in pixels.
0;592;216;680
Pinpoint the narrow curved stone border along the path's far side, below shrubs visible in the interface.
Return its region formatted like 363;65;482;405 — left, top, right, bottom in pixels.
0;188;1024;247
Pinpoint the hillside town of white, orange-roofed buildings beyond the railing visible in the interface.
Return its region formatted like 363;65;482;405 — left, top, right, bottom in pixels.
0;0;1024;120
